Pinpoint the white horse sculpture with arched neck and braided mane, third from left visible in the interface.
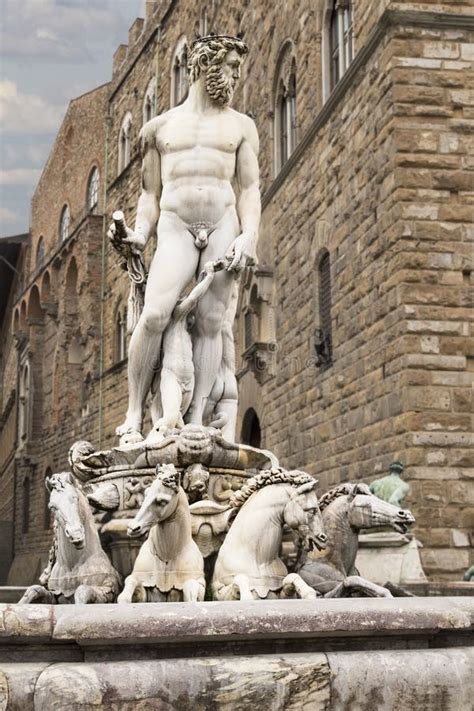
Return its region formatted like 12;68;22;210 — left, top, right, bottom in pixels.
212;468;326;600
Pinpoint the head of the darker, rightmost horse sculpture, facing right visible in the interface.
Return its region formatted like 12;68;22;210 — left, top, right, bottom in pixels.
347;484;415;533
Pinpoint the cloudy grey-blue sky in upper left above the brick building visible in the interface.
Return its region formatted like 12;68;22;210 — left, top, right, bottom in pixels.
0;0;145;237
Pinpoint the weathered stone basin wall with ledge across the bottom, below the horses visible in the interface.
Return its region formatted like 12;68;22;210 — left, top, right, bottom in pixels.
0;597;474;711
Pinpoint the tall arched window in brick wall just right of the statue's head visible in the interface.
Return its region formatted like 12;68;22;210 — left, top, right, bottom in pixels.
274;46;297;174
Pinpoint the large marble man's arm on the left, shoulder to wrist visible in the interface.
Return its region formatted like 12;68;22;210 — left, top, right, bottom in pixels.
134;124;161;248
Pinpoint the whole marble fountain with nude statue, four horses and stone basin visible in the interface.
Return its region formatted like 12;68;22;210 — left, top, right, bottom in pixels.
0;29;473;709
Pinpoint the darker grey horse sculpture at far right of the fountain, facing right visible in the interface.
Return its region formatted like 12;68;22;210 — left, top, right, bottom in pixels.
296;484;415;597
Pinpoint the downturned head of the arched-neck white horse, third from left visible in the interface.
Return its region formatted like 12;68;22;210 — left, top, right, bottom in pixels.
283;479;327;551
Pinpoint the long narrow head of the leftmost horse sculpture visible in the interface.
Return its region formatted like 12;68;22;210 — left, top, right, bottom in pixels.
45;472;86;549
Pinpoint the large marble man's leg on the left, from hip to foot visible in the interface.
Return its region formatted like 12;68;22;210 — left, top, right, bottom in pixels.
117;212;199;435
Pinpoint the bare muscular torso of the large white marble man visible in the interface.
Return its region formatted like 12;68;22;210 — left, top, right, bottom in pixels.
144;105;250;225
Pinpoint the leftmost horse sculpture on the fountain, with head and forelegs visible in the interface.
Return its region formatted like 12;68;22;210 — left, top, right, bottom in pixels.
20;472;120;604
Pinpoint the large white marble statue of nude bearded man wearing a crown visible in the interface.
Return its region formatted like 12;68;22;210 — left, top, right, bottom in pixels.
109;35;260;444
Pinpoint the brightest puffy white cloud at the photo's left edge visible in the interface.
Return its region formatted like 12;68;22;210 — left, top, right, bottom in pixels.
0;79;64;134
